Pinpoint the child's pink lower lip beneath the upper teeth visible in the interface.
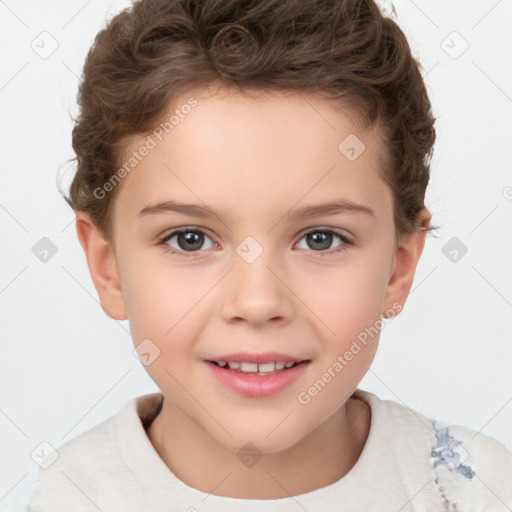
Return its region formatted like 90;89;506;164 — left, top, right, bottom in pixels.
206;361;309;398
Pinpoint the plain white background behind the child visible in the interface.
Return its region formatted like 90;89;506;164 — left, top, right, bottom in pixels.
0;0;512;511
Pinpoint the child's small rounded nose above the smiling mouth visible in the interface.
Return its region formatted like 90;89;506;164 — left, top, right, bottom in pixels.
222;252;295;326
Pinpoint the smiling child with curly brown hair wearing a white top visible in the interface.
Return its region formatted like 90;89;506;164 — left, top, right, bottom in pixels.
29;0;512;512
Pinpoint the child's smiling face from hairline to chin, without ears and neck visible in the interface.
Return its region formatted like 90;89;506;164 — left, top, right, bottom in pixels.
86;86;421;453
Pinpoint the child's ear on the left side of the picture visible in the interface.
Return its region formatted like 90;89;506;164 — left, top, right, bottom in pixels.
76;212;128;320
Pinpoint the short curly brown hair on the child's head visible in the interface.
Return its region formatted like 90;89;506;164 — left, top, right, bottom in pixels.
61;0;437;245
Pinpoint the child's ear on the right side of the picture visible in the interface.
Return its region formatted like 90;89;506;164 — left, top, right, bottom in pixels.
381;210;431;317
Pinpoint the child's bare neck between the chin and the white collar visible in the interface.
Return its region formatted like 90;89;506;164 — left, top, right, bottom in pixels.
147;398;370;499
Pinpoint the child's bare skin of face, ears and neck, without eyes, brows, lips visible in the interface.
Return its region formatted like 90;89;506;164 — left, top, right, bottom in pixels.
76;89;429;499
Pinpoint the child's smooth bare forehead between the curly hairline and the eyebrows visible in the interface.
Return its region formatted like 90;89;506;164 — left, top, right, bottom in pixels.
116;89;391;227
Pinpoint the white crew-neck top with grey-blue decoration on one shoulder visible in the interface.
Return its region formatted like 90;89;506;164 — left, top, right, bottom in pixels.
28;389;512;512
